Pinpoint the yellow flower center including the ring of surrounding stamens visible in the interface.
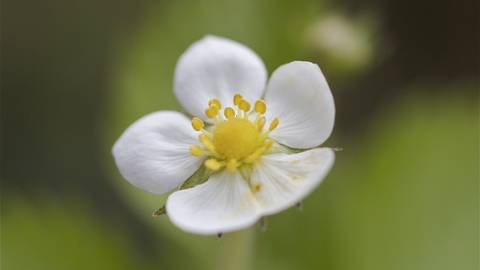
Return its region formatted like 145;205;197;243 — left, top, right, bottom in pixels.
190;94;278;171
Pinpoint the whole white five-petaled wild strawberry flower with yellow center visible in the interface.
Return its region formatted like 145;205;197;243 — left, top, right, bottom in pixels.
112;36;335;234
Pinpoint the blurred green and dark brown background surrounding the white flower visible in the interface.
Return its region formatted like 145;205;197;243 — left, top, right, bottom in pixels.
1;0;479;270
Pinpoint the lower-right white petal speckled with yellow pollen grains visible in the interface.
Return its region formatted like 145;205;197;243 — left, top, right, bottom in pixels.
250;148;335;215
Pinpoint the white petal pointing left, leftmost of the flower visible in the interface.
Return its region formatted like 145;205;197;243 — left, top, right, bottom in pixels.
112;111;204;194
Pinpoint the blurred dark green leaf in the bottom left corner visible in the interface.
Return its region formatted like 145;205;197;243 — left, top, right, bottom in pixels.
2;192;133;270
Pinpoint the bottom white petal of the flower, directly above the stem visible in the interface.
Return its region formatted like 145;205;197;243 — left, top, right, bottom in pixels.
167;170;261;234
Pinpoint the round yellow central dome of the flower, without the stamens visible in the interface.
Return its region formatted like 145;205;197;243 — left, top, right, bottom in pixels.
213;118;259;160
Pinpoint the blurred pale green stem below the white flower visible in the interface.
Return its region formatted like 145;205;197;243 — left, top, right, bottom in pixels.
217;226;255;270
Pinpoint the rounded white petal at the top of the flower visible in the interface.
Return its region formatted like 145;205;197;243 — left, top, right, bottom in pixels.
174;36;267;122
